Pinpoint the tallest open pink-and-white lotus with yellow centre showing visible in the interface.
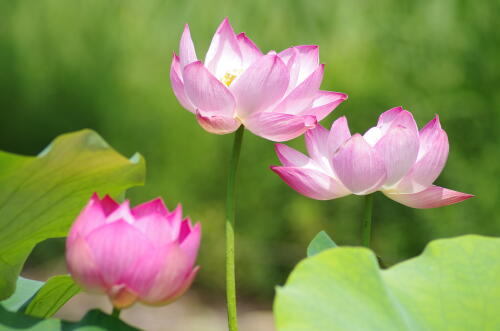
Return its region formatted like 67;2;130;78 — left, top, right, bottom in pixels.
170;18;347;141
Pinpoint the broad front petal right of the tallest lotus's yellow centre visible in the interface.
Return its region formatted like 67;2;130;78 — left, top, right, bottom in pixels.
230;54;289;118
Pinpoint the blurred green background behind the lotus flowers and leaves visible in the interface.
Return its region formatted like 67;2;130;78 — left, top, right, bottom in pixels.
0;0;500;302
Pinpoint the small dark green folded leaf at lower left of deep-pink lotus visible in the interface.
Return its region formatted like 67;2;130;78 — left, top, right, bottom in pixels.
24;275;80;318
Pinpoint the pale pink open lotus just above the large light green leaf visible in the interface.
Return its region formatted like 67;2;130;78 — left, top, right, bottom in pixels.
271;107;472;208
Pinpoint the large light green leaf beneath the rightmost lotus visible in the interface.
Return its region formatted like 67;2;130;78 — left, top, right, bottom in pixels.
274;236;500;331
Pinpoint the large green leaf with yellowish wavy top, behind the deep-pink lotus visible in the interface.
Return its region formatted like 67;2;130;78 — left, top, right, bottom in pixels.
0;130;145;299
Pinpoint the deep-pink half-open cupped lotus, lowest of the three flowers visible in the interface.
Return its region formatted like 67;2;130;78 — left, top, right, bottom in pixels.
66;194;201;308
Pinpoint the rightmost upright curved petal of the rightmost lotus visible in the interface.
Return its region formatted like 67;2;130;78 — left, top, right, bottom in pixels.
396;117;449;193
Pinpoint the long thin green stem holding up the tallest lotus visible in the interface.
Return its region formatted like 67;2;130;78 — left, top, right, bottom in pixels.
226;125;245;331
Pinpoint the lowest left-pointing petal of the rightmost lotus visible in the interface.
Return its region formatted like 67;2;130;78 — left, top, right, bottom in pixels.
271;166;351;200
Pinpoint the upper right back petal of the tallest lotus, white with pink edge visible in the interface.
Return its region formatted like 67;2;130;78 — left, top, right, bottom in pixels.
278;45;319;90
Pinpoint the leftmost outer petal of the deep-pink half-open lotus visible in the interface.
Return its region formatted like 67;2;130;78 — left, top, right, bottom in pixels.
66;235;106;293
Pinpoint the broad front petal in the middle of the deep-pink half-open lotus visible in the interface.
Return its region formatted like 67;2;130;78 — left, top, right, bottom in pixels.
84;220;154;286
